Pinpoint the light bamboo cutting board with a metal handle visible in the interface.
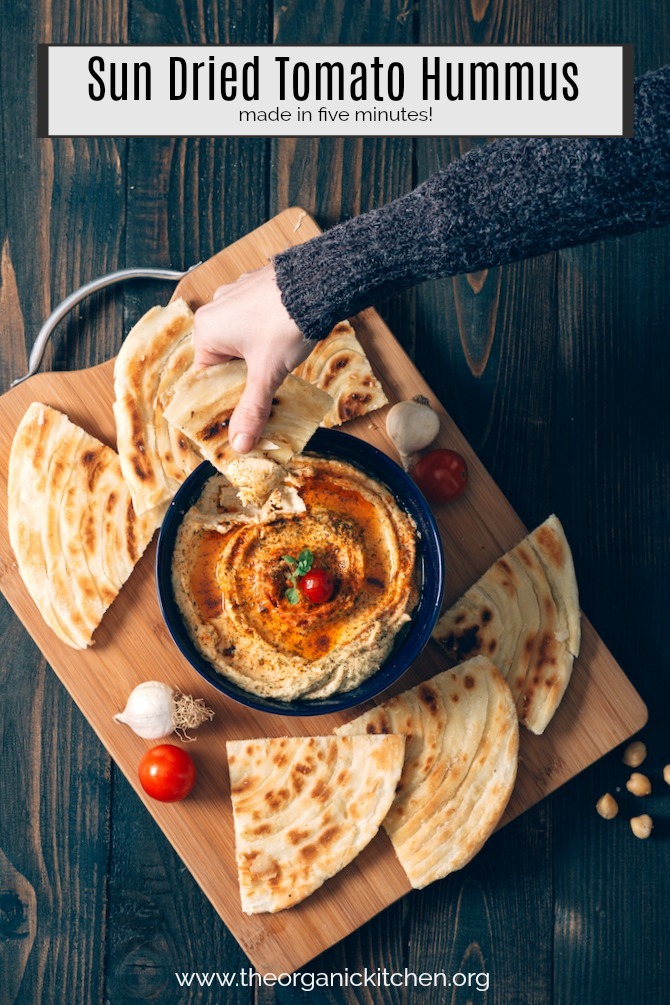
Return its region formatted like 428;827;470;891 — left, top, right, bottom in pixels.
0;208;647;973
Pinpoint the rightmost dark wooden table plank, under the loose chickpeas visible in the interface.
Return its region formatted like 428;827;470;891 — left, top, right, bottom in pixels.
550;7;670;1005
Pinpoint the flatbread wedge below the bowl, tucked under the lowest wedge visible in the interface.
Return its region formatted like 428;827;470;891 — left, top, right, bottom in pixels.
336;656;518;889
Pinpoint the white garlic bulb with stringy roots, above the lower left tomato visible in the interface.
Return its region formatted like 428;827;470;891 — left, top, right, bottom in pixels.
114;680;214;740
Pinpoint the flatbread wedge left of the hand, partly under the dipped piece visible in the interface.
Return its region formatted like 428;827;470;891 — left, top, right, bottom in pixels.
114;297;202;522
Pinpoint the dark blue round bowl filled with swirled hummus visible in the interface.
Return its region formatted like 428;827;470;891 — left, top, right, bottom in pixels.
157;430;442;714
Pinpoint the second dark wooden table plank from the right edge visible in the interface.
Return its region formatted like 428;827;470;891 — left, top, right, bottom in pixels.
415;0;562;1005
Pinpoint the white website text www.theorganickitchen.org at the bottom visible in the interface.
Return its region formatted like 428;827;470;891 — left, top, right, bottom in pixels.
175;967;489;991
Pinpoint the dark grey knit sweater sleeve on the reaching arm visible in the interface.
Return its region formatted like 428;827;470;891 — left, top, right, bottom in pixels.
274;66;670;339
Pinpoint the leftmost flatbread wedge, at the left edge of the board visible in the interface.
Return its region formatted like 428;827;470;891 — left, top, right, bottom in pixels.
8;402;156;649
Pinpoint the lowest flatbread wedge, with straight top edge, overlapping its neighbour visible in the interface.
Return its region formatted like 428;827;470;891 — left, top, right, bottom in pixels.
226;736;405;915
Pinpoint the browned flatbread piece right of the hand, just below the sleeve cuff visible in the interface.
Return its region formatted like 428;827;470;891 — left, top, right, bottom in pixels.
293;321;389;428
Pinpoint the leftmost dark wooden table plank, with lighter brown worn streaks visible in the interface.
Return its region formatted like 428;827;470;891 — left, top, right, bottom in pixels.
0;0;126;1005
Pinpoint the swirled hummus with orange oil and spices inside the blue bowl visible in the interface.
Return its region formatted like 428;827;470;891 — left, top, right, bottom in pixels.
173;456;417;700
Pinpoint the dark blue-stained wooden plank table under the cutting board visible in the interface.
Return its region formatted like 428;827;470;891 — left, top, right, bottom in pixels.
0;0;670;1005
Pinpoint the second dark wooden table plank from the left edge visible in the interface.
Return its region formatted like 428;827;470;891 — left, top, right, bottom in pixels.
98;2;269;1005
